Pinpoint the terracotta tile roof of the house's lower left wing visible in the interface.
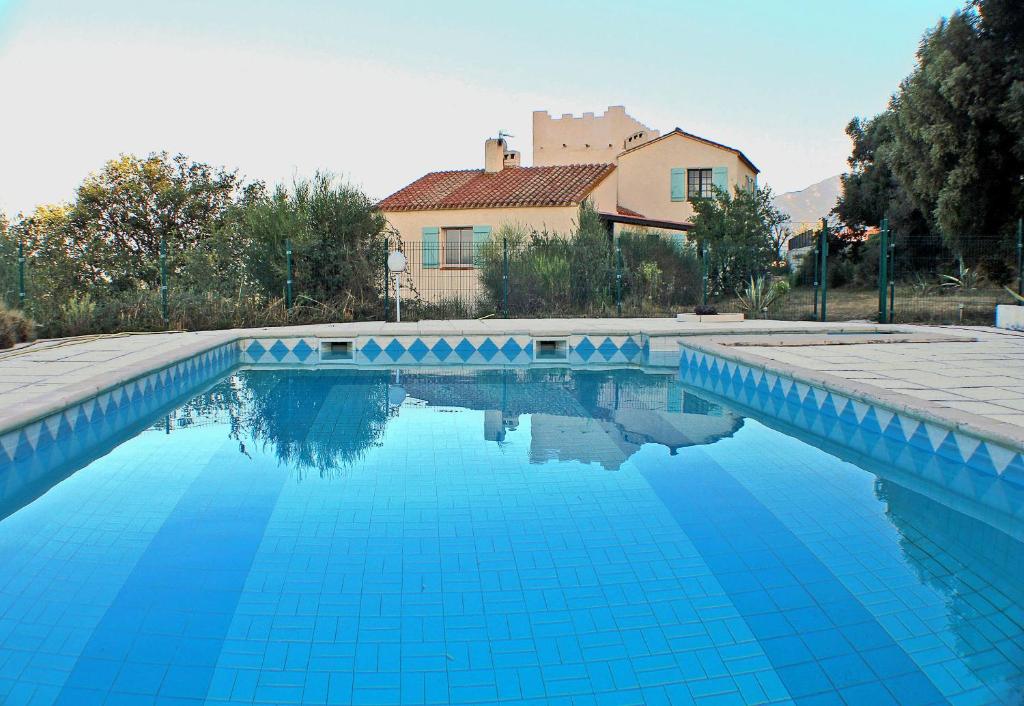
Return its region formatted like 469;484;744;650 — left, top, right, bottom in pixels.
377;164;615;211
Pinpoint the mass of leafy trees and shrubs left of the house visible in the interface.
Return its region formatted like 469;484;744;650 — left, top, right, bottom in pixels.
0;153;395;334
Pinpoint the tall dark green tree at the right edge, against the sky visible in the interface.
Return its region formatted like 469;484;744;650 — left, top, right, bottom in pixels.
836;0;1024;251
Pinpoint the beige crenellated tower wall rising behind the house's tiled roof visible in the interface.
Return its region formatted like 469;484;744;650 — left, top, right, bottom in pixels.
534;106;658;167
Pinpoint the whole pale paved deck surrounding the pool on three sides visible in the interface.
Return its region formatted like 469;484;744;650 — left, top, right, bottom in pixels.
0;319;1024;448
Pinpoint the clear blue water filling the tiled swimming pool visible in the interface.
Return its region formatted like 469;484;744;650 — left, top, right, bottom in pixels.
0;369;1024;706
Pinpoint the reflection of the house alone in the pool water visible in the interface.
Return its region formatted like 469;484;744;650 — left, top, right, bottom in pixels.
402;370;742;469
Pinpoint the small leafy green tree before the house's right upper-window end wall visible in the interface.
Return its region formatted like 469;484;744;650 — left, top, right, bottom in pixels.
688;186;788;296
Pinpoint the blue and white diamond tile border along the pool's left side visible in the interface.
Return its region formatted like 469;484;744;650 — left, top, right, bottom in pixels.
0;342;239;473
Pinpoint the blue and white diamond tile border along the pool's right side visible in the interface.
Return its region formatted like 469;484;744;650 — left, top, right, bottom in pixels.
679;346;1024;497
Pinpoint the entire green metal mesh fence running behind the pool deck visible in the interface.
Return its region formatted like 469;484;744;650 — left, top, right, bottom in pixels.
0;225;1020;336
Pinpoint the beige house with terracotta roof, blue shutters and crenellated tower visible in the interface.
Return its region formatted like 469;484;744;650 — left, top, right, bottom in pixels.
378;106;758;299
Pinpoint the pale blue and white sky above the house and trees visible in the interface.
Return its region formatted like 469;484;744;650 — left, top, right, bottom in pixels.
0;0;962;215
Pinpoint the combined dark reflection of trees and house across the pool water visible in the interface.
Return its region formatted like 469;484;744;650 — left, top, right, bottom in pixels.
158;368;742;479
